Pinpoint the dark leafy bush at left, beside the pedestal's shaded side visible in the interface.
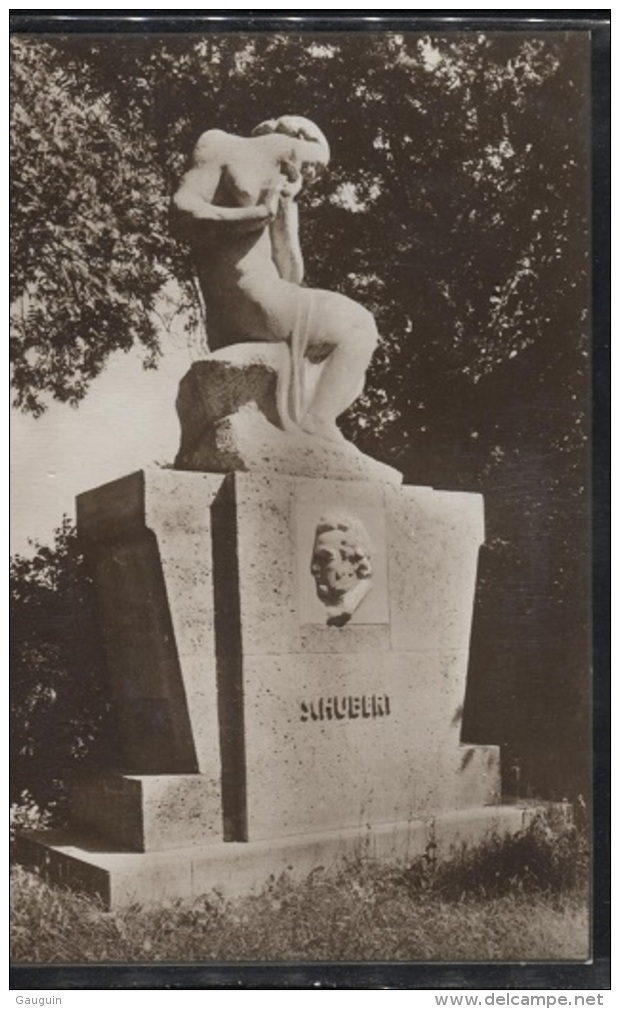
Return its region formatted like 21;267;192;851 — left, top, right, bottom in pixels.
9;520;110;808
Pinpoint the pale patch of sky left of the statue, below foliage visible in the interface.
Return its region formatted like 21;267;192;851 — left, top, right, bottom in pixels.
10;324;196;556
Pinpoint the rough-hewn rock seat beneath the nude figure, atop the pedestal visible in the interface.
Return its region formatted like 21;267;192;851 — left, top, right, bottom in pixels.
175;343;402;485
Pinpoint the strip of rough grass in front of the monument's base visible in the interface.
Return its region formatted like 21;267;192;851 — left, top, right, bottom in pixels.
11;822;589;964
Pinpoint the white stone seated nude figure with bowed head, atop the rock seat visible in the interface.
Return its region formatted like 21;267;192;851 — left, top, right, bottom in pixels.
173;116;378;441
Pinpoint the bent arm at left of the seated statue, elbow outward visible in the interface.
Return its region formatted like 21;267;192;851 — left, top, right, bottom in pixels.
173;130;274;230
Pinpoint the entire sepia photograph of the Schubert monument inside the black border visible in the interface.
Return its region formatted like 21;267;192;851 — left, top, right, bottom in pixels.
10;19;593;984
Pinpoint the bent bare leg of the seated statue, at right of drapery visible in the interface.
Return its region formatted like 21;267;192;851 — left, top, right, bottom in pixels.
301;292;379;441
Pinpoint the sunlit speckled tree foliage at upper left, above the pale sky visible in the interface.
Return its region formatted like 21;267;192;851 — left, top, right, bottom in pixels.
10;38;193;414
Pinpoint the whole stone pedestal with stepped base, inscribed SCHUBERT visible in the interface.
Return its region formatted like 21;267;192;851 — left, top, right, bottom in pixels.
17;470;521;903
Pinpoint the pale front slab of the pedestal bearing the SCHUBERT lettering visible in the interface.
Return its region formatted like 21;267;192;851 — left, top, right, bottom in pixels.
211;474;499;840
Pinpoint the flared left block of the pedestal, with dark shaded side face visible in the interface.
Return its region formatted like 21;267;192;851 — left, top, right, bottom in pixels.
77;469;227;778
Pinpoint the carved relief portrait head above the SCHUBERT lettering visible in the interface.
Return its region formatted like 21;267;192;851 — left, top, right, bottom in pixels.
310;515;373;606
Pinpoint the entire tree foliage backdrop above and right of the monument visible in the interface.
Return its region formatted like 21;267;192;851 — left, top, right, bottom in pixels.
11;32;589;799
